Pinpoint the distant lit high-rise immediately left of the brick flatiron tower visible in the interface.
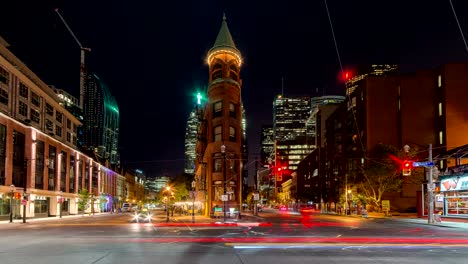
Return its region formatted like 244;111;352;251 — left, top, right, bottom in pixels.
184;107;200;174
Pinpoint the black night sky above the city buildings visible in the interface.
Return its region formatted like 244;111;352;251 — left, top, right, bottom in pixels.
0;0;468;175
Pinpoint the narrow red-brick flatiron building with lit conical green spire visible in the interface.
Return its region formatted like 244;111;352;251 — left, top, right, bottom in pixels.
195;16;245;214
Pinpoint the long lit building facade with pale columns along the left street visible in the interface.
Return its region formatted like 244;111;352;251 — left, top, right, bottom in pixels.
0;35;139;219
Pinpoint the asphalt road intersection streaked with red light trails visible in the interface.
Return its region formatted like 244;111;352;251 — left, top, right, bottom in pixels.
0;211;468;264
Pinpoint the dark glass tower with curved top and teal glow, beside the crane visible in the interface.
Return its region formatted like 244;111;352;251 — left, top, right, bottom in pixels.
82;73;120;164
